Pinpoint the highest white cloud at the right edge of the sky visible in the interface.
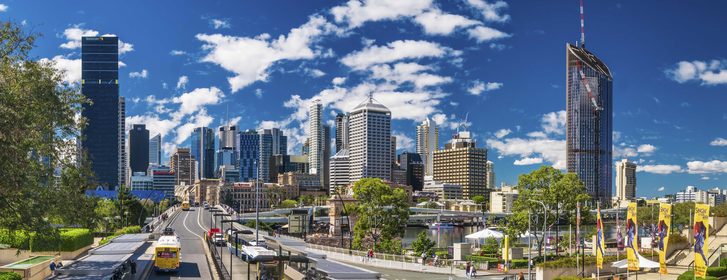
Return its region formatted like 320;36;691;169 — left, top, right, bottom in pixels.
664;60;727;85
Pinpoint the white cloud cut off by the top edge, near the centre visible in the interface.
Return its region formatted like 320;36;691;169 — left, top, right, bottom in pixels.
331;0;432;28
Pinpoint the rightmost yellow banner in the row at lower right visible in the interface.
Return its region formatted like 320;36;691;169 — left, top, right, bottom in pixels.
694;203;709;278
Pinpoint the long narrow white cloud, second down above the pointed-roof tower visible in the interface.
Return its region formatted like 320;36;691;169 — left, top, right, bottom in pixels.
341;40;449;70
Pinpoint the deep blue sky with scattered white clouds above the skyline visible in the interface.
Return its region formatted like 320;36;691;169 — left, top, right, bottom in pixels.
0;0;727;196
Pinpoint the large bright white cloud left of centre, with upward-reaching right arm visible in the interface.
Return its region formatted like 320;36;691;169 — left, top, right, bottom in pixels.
196;16;339;93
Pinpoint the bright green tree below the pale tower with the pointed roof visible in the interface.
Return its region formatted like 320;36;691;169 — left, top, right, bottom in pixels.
353;178;409;250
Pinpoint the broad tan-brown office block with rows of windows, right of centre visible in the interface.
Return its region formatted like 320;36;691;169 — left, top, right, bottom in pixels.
433;131;490;200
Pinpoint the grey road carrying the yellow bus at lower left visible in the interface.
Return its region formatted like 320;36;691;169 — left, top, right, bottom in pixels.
149;207;212;279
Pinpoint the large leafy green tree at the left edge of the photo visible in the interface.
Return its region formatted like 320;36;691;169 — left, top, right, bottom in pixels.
0;22;95;237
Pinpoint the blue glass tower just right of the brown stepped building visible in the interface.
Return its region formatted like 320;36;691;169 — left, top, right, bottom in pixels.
192;127;215;179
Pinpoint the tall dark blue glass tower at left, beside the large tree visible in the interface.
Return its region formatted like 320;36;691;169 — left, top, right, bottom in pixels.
81;37;119;190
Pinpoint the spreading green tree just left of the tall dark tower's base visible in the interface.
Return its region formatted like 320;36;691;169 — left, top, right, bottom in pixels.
505;166;590;256
